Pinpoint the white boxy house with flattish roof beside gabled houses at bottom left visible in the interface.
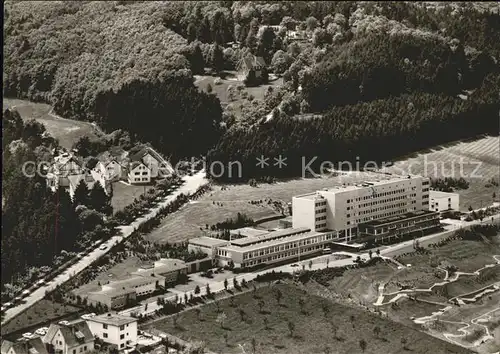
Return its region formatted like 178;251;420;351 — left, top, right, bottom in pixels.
87;313;137;350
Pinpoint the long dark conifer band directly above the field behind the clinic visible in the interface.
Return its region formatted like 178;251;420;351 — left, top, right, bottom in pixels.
207;74;500;180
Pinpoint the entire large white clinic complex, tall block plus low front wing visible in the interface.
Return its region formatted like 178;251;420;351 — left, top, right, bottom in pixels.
188;175;440;268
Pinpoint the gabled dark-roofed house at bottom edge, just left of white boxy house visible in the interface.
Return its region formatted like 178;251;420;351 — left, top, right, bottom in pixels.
42;319;94;354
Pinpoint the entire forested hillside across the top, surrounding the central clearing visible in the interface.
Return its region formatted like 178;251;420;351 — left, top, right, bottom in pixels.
4;1;500;175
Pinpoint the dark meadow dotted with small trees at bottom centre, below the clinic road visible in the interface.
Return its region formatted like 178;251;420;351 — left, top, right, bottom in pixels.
148;284;469;354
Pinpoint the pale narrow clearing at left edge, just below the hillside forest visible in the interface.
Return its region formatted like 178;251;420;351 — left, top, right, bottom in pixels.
3;98;97;149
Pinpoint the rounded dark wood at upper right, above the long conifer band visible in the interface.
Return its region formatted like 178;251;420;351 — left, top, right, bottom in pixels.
302;34;498;112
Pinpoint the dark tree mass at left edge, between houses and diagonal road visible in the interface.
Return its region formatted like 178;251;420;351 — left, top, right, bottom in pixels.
1;110;110;290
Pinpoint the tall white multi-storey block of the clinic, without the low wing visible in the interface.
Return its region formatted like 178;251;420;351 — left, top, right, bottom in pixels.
292;176;430;241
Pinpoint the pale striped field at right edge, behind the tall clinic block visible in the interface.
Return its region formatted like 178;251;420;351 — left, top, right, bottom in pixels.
385;136;500;211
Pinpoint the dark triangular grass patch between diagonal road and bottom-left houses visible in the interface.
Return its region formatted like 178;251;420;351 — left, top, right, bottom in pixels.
1;299;81;336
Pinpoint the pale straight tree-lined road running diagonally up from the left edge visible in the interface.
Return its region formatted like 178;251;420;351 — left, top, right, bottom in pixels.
1;170;208;325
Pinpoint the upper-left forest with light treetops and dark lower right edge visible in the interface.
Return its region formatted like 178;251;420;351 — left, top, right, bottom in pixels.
4;1;222;158
